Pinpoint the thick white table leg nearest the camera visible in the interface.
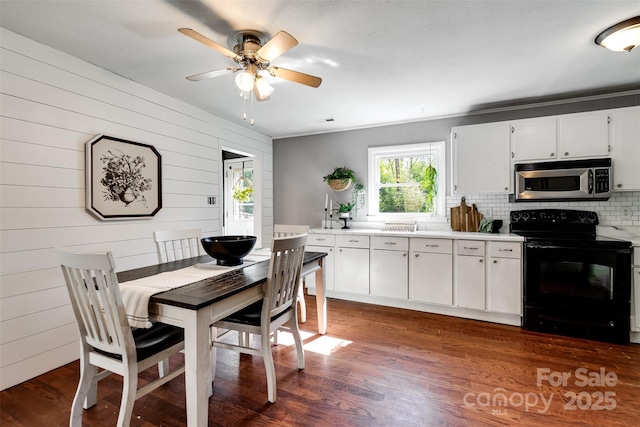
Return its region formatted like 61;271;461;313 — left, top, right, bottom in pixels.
184;309;211;427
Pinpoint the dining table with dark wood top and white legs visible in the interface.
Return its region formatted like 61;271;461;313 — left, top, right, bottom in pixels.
117;252;327;426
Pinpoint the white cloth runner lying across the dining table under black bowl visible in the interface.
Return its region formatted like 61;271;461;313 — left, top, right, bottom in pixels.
120;250;270;328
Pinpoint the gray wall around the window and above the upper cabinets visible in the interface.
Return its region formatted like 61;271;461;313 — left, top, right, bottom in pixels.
273;91;640;227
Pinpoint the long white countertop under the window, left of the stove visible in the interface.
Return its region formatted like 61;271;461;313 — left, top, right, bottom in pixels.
309;228;524;242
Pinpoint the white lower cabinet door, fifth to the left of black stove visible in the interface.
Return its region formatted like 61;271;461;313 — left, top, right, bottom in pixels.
334;247;369;295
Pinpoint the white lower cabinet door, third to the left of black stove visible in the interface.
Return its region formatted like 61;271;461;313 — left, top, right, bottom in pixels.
409;252;453;305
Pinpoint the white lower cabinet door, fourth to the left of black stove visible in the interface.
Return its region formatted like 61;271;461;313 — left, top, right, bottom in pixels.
370;249;409;300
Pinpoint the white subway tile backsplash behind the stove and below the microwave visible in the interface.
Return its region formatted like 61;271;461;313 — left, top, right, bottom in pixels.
447;191;640;226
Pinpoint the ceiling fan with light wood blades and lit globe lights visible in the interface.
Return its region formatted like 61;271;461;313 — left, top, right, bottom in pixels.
178;28;322;101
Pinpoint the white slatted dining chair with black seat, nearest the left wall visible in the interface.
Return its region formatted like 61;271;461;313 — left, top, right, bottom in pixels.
56;248;185;427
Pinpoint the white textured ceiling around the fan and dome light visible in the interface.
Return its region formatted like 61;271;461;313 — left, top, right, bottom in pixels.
0;0;640;138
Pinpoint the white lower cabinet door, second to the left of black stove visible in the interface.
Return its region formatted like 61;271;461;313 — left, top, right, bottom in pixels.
454;256;485;310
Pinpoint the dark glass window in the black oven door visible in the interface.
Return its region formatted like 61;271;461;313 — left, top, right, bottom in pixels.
539;260;613;300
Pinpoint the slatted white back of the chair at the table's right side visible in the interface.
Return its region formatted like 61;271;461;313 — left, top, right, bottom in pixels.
261;234;307;324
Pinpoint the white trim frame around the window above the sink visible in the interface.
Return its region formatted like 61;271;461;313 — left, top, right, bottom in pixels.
367;141;447;222
